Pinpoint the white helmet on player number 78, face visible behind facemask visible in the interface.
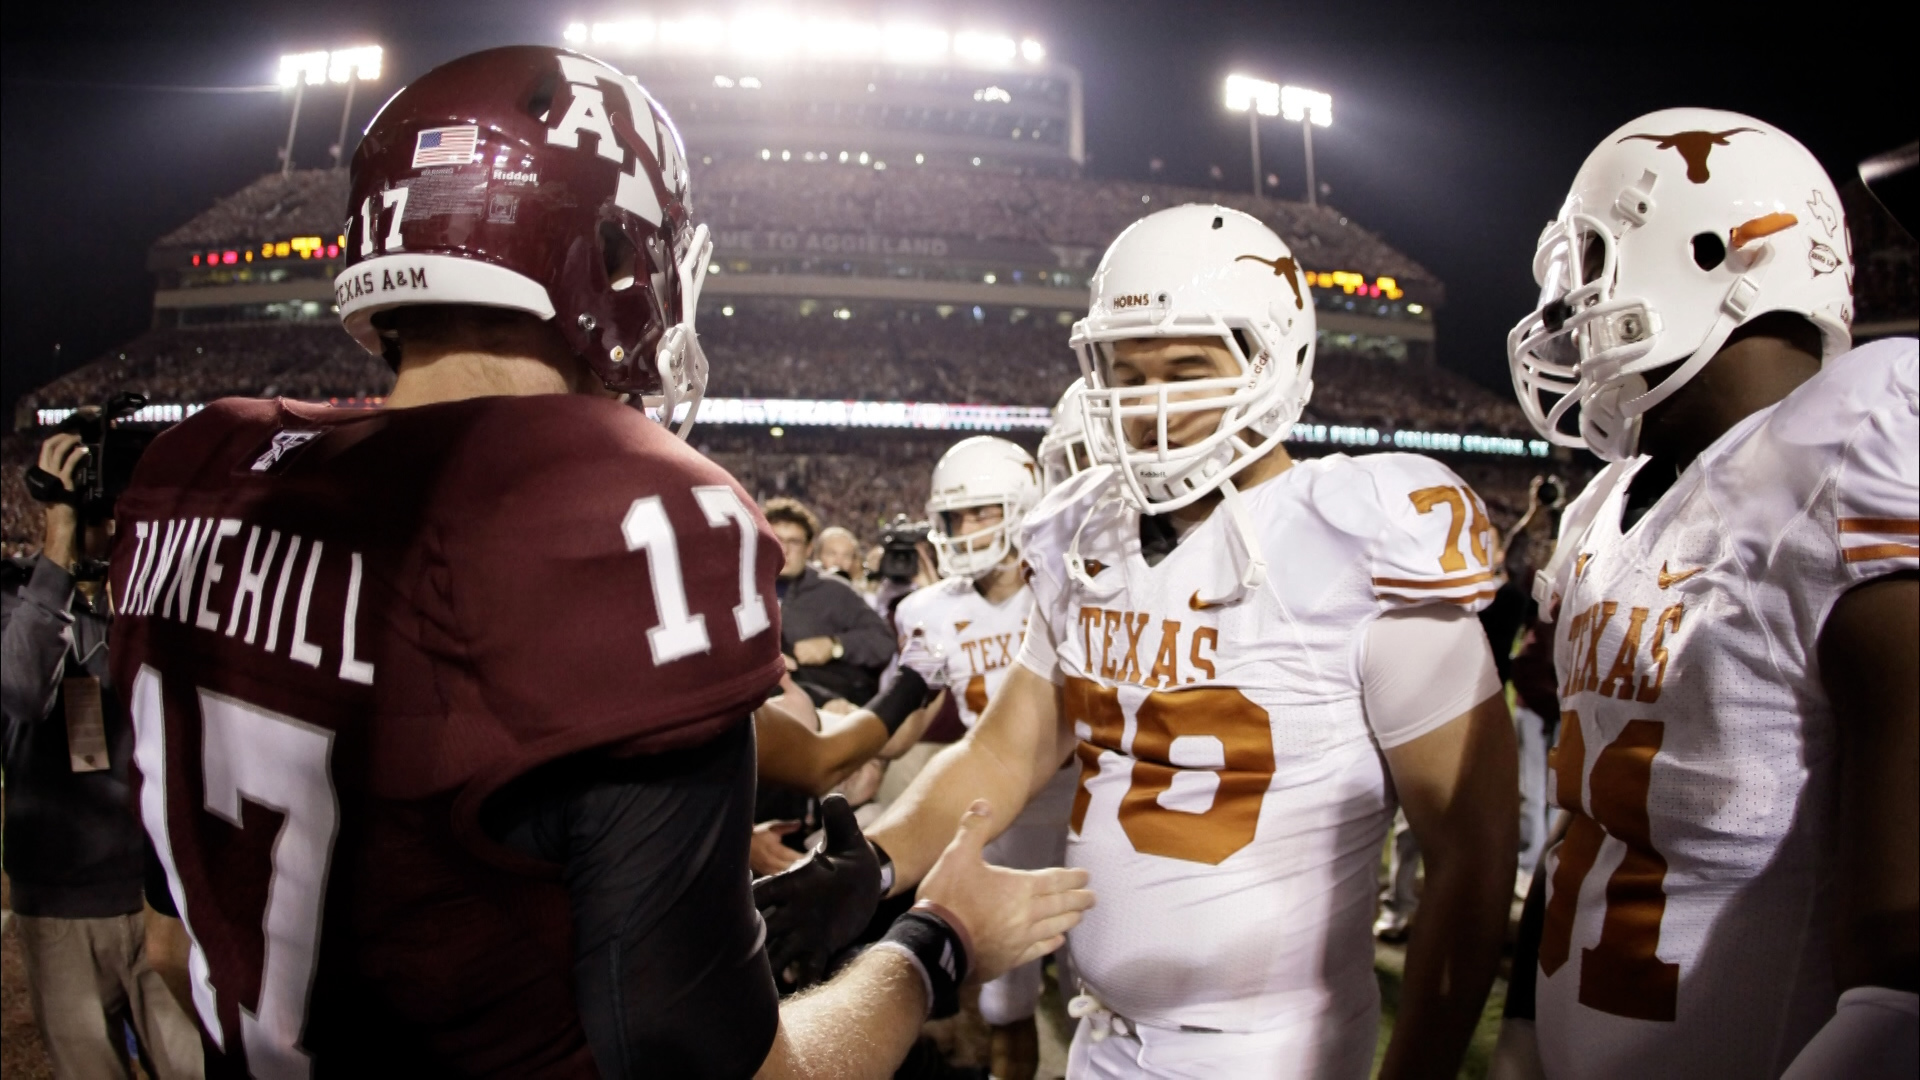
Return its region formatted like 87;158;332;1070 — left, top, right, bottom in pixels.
1071;206;1315;513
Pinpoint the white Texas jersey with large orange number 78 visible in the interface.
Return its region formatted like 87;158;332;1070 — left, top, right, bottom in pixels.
1021;454;1498;1045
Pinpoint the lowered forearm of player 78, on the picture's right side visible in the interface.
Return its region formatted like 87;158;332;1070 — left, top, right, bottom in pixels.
1380;842;1513;1080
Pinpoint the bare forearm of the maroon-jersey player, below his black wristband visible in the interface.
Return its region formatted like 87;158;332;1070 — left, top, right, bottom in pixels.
755;949;927;1080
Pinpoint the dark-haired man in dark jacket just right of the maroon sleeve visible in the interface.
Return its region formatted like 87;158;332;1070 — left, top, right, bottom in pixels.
764;498;895;705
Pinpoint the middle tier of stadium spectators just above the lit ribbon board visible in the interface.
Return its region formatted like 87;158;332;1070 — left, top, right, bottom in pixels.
19;300;1528;428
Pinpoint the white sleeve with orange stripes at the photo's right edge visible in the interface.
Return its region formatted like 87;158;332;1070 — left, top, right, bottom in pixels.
1832;340;1920;582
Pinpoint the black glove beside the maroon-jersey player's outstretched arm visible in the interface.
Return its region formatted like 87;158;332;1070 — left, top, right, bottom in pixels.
753;796;881;990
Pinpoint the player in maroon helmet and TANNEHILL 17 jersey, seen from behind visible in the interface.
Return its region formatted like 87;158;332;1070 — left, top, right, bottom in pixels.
111;48;1091;1076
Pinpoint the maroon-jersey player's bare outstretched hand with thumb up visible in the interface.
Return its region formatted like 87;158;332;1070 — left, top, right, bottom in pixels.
916;799;1094;982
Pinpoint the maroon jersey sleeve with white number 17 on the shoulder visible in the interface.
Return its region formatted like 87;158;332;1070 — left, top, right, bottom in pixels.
441;398;783;790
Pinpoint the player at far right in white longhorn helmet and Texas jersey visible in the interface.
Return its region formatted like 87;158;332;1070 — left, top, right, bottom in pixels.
1503;110;1920;1078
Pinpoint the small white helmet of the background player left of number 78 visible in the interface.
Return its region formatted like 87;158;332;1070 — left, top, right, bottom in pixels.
927;434;1041;578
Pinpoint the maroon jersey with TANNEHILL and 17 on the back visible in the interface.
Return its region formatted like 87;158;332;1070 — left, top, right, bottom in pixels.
111;396;781;1076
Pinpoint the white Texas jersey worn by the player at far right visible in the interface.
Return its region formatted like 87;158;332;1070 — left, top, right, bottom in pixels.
1536;338;1920;1078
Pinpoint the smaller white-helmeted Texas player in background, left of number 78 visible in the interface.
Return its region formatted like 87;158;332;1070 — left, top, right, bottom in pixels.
895;434;1077;1080
